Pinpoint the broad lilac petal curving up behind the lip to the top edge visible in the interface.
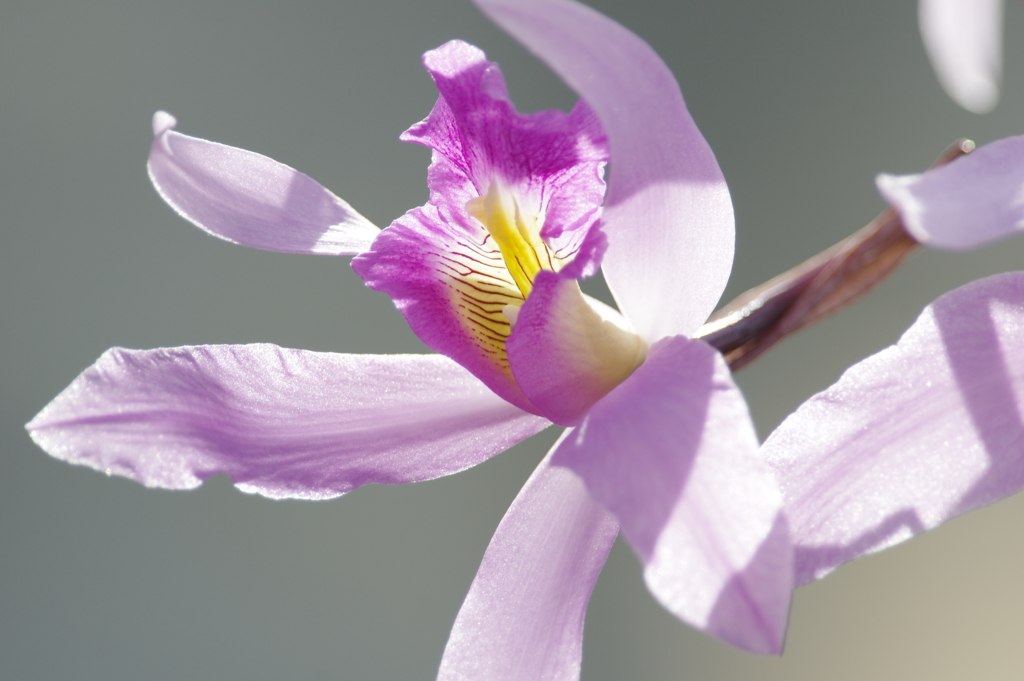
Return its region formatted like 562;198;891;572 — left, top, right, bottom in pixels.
475;0;735;342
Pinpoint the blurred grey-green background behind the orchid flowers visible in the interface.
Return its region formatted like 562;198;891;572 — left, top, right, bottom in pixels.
6;0;1024;681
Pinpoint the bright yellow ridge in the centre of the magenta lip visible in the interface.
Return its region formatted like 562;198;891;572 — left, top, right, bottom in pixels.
466;182;555;299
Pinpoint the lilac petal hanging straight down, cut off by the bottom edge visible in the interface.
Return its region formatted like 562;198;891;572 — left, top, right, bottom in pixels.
437;435;618;681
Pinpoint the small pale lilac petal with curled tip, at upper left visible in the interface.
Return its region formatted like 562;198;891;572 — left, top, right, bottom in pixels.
148;112;379;255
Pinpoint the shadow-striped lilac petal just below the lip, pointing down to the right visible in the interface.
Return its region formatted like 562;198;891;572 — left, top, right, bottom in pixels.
552;336;793;652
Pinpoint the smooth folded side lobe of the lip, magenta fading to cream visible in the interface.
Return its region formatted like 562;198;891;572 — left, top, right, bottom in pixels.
506;271;647;426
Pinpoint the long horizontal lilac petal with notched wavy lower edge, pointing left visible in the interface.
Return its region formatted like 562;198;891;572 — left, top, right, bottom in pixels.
27;344;547;499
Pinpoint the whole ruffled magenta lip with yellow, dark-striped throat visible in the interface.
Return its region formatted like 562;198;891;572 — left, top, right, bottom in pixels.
352;41;647;426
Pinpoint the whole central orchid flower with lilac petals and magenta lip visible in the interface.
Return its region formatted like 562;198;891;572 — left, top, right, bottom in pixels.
28;0;793;679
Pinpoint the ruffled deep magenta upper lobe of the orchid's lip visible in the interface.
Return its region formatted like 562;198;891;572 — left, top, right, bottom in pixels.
401;40;608;269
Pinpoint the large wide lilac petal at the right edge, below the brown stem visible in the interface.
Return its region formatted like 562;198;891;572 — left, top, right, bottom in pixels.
763;272;1024;583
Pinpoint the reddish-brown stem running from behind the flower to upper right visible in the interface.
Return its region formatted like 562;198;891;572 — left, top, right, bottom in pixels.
695;139;974;371
